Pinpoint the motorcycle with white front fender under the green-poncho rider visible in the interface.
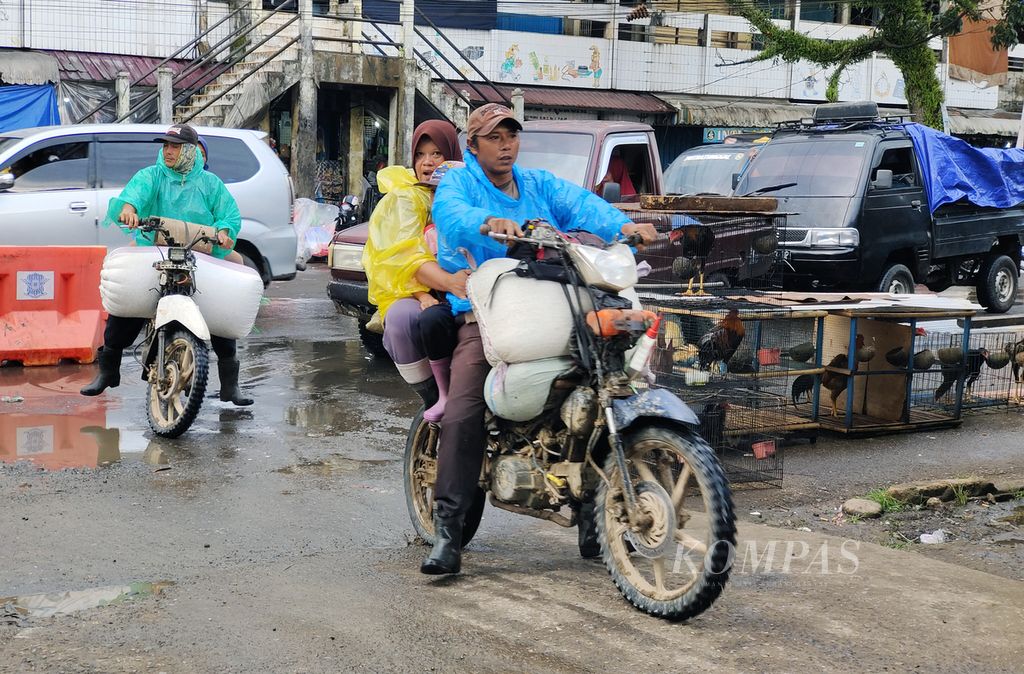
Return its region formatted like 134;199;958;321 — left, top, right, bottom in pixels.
138;217;217;437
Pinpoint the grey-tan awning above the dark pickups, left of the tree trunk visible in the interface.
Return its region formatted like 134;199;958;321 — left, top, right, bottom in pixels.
659;93;814;128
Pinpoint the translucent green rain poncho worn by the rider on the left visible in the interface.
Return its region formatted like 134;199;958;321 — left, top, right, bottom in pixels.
103;148;242;258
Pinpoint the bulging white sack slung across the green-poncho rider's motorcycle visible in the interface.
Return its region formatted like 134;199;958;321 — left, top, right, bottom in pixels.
99;246;263;339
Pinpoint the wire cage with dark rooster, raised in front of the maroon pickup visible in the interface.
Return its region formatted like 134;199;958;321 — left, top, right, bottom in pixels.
628;209;785;295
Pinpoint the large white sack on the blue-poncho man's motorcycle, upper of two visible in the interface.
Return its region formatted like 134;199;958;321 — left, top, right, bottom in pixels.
467;257;593;366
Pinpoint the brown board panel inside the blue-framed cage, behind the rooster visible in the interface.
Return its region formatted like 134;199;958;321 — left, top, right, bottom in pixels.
820;315;910;421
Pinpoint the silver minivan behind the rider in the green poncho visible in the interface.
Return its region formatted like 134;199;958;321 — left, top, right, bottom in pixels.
0;124;297;283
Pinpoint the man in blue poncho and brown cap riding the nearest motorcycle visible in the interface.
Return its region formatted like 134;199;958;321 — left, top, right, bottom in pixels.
420;103;656;575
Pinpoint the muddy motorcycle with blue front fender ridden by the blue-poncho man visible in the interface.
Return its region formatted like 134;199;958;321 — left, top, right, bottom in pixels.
403;221;735;620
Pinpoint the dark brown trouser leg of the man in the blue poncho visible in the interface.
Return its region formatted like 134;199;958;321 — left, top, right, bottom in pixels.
434;323;490;517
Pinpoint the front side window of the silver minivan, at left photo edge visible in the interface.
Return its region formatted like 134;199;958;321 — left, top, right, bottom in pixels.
0;140;89;194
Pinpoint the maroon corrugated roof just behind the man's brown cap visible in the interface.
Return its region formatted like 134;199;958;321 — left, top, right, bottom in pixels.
449;83;676;115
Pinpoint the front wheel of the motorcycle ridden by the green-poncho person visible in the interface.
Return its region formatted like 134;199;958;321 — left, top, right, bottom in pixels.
145;328;210;437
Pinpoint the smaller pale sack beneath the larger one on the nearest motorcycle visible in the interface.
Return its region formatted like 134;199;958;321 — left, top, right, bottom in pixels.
483;357;572;421
